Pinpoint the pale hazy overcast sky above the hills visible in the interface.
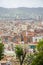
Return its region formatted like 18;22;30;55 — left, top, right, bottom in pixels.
0;0;43;8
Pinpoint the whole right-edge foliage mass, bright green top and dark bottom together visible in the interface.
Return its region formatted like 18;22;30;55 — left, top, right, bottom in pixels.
31;40;43;65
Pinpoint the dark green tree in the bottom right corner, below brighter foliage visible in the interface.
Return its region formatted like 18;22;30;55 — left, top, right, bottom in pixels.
31;52;43;65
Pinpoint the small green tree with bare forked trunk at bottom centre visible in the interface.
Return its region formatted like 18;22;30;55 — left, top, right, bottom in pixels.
15;46;26;65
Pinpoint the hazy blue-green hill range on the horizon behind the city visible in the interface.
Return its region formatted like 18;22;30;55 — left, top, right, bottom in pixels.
0;7;43;20
